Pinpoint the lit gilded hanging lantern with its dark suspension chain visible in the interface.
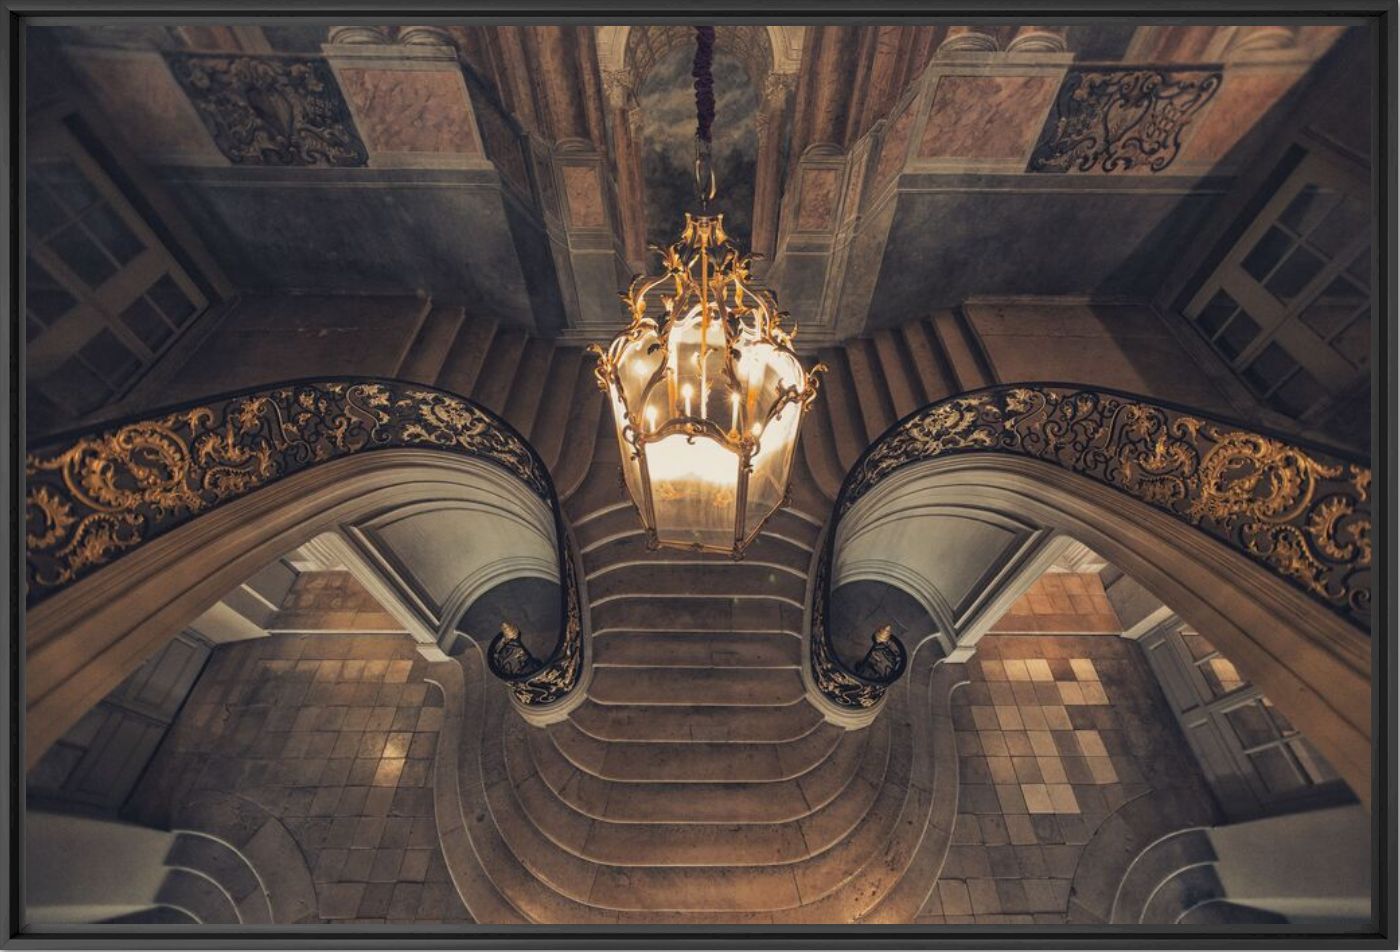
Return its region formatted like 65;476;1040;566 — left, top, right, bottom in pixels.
591;27;826;559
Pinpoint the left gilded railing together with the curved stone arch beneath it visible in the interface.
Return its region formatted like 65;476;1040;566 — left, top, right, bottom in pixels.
25;381;584;764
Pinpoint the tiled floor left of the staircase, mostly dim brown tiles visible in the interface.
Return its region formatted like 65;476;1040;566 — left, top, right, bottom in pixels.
132;633;468;923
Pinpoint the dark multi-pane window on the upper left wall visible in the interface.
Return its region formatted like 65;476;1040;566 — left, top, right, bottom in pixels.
25;125;207;416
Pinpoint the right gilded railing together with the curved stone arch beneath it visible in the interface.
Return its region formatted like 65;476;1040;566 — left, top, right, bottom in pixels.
808;385;1372;801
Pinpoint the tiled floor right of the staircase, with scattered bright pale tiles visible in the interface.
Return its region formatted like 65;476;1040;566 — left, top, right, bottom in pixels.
921;636;1210;923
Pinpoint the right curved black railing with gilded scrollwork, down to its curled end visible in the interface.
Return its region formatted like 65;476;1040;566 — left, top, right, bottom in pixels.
809;384;1372;707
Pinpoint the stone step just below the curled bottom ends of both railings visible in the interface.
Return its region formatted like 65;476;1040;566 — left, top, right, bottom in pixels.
570;700;825;743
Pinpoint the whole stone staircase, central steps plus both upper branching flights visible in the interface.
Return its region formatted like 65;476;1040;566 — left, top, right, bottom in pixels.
399;308;991;923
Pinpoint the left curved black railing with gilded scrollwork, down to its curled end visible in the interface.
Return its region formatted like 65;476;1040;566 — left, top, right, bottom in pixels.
25;378;584;704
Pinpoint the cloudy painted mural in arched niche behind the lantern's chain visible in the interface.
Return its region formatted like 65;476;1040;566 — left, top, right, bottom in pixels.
637;45;759;246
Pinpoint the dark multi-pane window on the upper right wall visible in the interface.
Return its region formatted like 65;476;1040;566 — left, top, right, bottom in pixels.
1186;151;1372;421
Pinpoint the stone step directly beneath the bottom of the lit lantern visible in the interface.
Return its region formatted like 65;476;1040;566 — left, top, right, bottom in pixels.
588;550;806;605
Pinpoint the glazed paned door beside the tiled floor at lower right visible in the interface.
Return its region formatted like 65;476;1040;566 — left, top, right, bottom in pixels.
1141;622;1347;819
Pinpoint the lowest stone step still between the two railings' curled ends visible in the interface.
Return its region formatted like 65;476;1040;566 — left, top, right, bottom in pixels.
588;666;806;708
